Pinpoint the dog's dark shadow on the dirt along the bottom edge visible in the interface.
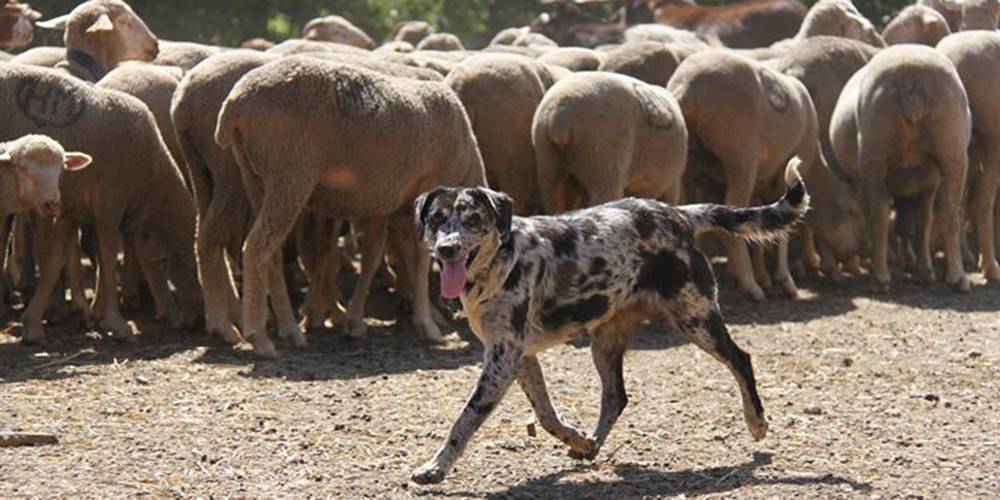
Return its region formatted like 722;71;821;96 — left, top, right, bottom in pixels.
428;452;872;499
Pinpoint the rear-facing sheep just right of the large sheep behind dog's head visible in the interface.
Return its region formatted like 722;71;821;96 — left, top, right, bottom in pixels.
445;54;546;215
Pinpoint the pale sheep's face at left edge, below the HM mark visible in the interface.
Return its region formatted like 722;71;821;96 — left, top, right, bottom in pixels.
0;136;91;217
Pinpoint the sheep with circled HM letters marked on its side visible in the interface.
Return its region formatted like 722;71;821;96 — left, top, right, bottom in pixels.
0;65;201;342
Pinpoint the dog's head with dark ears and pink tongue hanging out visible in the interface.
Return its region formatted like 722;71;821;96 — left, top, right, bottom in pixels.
414;187;514;299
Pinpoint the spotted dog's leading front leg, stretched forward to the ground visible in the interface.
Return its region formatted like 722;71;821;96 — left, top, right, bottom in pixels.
410;342;524;484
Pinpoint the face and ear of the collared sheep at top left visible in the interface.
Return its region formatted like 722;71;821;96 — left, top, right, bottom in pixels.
57;0;159;69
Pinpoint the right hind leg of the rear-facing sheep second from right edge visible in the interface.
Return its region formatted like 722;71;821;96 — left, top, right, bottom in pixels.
937;146;971;292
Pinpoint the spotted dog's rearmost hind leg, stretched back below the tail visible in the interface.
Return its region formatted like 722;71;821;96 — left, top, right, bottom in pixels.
669;290;767;440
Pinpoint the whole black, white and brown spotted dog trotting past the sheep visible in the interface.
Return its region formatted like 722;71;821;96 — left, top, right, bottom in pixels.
412;181;809;484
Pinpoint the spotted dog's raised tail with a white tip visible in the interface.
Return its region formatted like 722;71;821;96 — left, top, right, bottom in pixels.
677;158;809;242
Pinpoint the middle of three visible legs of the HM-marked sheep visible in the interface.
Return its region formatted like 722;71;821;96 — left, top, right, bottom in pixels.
94;222;135;341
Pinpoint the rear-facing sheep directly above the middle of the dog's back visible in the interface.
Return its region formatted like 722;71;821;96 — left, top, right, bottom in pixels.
532;72;688;214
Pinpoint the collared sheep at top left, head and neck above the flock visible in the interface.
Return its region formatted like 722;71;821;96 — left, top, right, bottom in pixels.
37;0;159;82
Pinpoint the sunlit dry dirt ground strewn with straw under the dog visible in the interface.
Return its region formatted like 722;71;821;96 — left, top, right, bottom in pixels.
0;272;1000;499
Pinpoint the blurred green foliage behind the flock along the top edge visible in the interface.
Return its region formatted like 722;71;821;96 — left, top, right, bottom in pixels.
23;0;910;47
